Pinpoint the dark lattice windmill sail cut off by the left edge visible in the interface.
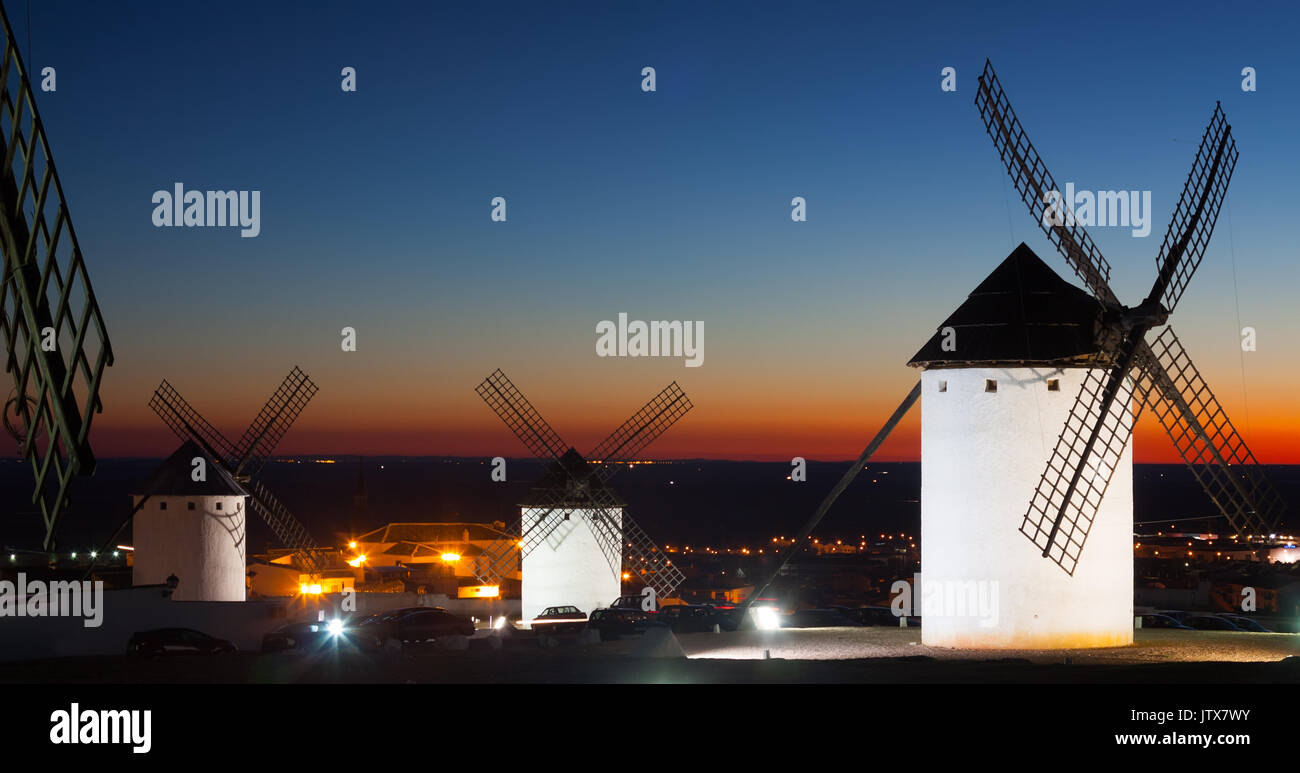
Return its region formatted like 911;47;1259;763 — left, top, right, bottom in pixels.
0;8;113;551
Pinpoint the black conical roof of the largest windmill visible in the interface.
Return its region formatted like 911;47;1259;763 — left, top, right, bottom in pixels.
907;242;1101;368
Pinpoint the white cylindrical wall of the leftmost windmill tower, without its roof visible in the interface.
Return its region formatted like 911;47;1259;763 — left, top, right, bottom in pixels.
131;496;247;602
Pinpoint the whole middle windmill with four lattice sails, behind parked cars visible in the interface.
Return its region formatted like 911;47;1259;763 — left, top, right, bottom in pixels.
476;370;692;620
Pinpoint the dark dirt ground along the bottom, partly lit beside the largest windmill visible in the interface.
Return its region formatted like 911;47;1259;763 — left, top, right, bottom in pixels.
0;627;1300;685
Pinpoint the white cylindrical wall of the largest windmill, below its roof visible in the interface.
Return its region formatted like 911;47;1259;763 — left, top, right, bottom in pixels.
917;368;1134;648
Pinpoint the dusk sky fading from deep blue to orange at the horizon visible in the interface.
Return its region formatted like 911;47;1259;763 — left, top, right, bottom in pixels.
5;0;1300;461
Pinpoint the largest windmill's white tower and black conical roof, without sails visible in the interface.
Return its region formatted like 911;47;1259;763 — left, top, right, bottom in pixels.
909;244;1134;650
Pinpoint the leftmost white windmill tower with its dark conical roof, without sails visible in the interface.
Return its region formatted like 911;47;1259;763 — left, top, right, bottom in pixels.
131;442;247;602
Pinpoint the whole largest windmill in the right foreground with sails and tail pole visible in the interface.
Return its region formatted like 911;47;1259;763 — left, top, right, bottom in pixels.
746;62;1286;648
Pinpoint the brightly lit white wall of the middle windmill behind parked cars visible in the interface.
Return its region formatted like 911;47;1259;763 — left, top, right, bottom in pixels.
520;508;623;621
